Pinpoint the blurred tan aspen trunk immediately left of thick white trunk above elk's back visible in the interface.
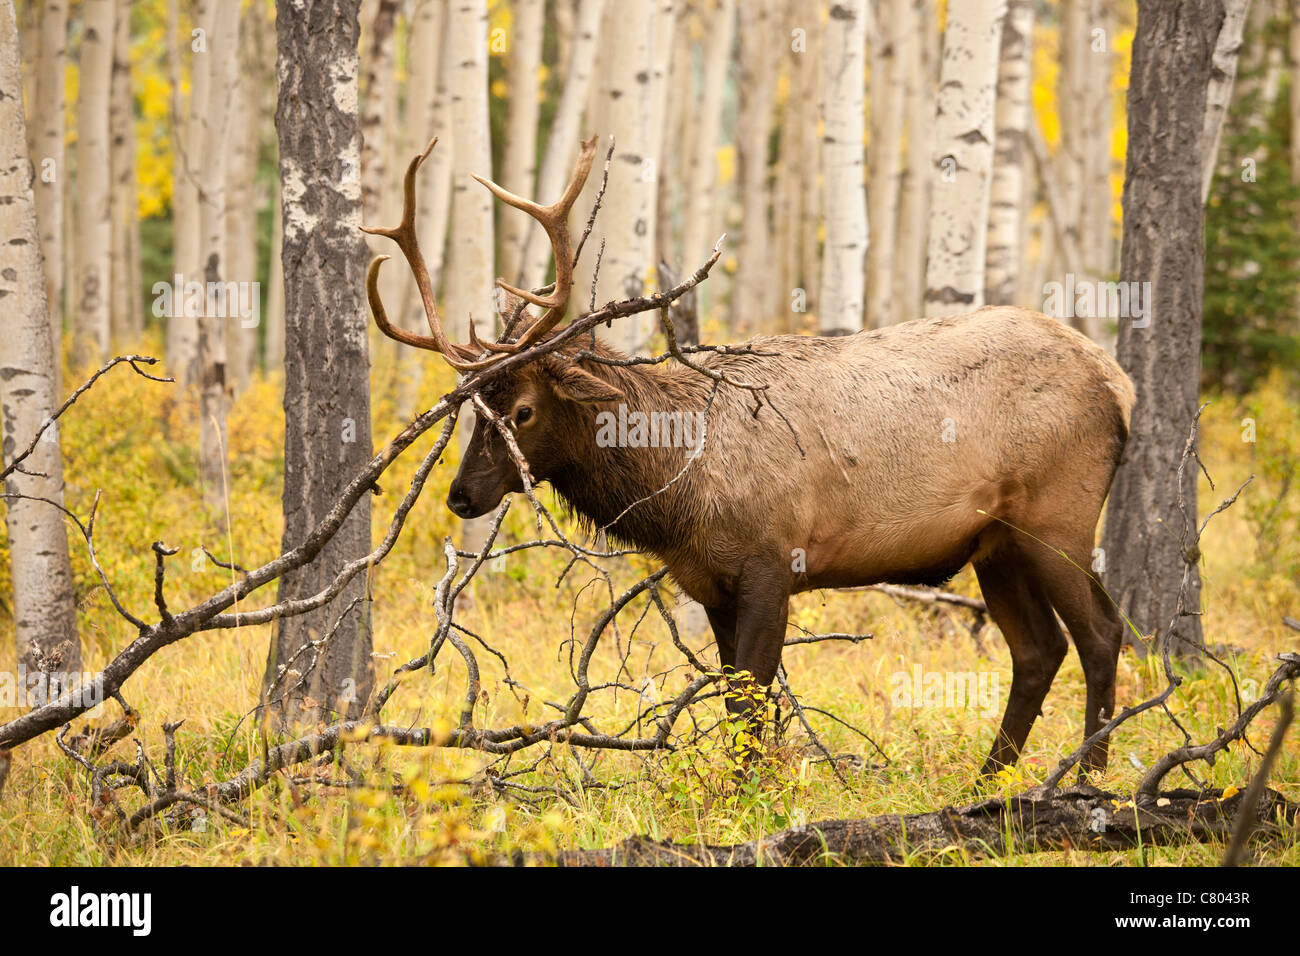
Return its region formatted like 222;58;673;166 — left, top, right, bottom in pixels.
894;0;939;320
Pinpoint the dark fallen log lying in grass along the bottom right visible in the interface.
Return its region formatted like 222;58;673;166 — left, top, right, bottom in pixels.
540;784;1300;866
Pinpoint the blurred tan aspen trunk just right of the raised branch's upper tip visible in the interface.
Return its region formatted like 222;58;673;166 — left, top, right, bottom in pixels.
731;0;777;338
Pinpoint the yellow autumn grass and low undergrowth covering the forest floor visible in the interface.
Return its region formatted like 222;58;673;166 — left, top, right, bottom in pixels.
0;338;1300;866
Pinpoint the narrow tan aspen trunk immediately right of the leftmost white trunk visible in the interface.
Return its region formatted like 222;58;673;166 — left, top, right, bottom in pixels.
31;0;68;377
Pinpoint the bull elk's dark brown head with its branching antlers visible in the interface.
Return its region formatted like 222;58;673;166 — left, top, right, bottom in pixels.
363;137;621;518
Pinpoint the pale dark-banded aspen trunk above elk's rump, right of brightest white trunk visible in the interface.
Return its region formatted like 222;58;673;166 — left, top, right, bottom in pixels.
984;0;1034;306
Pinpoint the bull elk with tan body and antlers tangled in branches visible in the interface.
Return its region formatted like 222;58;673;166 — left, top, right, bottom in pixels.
367;137;1134;774
